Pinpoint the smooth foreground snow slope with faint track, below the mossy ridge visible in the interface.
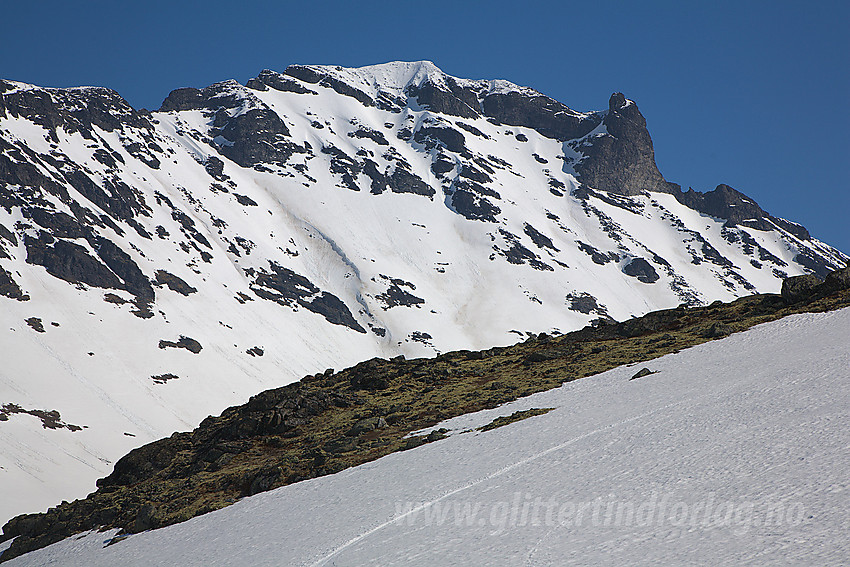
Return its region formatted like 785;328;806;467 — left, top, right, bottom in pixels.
9;309;850;566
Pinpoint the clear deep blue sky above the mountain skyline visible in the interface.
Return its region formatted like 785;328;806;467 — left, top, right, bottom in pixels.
0;0;850;253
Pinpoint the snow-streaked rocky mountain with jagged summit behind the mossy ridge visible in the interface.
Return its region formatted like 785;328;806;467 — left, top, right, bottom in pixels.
0;62;848;519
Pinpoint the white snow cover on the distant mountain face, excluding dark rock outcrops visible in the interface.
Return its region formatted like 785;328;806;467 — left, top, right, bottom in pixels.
0;62;845;524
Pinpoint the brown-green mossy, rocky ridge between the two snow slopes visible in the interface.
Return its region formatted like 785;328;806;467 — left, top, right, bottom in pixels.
0;268;850;562
